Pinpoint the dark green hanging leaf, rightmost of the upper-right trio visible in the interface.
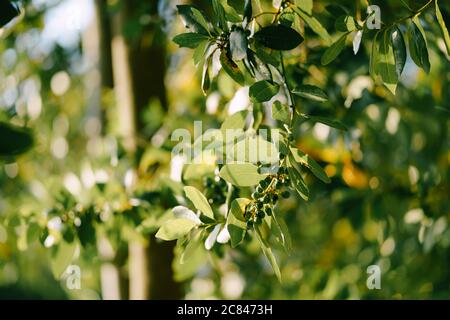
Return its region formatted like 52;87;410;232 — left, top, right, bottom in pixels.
409;16;430;73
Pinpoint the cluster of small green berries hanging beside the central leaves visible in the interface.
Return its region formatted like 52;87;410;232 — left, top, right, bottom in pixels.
244;167;290;228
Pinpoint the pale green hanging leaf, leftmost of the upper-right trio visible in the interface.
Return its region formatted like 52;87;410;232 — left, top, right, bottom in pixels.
375;28;398;94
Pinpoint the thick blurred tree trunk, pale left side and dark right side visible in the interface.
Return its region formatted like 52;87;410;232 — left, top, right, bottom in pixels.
112;0;181;299
